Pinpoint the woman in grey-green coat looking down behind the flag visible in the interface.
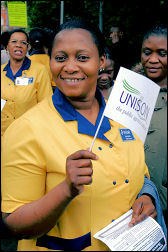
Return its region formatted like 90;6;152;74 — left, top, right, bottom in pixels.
141;24;167;224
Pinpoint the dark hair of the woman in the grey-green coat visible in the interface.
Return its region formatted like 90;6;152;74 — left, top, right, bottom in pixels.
142;24;167;44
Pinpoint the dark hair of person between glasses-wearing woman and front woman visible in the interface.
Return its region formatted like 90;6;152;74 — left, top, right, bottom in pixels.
29;27;47;50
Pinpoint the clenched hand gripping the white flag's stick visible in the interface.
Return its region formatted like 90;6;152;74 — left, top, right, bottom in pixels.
66;150;98;197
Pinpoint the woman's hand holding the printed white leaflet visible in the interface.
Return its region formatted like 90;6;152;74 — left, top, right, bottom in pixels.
129;195;157;227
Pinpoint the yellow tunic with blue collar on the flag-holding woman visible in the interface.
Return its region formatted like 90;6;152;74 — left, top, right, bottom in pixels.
2;88;149;251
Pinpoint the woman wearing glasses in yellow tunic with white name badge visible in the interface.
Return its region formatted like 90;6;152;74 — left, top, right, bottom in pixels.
1;29;53;136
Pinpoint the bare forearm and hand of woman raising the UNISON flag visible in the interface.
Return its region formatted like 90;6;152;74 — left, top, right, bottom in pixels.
3;150;97;239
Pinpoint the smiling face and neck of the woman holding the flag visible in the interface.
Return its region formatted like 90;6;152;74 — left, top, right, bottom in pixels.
50;28;105;113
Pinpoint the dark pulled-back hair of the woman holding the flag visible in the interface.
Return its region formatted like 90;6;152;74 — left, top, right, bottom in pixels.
48;19;105;58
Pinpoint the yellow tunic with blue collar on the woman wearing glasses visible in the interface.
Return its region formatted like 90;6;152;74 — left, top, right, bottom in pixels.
1;57;53;136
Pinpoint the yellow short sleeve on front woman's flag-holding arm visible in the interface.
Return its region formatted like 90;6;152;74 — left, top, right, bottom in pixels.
1;117;46;213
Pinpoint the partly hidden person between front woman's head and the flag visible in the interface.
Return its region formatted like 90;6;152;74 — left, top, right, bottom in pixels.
97;47;115;99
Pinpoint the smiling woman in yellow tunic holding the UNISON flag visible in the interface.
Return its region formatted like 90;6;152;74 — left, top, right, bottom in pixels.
2;19;167;251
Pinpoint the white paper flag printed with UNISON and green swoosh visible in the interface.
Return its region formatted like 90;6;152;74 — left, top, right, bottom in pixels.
103;67;160;143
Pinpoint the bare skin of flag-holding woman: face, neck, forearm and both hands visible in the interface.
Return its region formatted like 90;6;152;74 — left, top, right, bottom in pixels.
3;29;156;238
